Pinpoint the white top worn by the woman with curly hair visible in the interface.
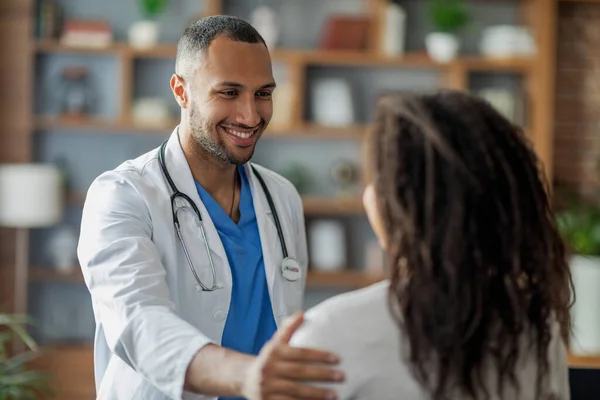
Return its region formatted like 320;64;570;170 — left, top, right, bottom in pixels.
290;281;570;400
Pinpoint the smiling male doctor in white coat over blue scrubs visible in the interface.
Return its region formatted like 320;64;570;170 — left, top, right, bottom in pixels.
78;15;343;400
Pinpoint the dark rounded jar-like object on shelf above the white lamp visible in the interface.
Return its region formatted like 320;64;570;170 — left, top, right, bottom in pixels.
59;66;94;118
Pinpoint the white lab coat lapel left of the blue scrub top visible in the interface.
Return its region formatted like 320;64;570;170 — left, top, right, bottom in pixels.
165;128;229;270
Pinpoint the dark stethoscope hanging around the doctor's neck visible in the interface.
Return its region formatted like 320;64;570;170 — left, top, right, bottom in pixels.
158;141;302;292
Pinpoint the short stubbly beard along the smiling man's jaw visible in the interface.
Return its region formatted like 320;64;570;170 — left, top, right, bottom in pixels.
190;102;254;165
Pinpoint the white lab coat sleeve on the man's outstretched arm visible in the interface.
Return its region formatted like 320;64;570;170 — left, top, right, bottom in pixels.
78;171;212;399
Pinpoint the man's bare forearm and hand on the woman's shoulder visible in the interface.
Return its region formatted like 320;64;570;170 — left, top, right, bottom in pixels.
186;313;344;400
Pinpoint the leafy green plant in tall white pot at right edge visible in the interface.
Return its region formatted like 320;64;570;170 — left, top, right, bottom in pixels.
556;184;600;355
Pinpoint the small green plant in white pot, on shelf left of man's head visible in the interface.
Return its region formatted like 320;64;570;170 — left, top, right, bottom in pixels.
129;0;167;49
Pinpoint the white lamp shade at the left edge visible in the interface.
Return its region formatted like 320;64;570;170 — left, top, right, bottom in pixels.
0;164;63;228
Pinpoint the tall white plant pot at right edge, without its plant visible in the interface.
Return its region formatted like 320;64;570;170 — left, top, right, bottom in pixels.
569;255;600;356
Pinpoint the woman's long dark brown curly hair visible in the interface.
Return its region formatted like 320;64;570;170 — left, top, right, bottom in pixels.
366;91;572;399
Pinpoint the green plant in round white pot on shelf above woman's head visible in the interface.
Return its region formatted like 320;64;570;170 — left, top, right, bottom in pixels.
425;0;470;63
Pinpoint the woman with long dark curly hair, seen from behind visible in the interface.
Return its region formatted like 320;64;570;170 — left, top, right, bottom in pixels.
295;91;572;400
